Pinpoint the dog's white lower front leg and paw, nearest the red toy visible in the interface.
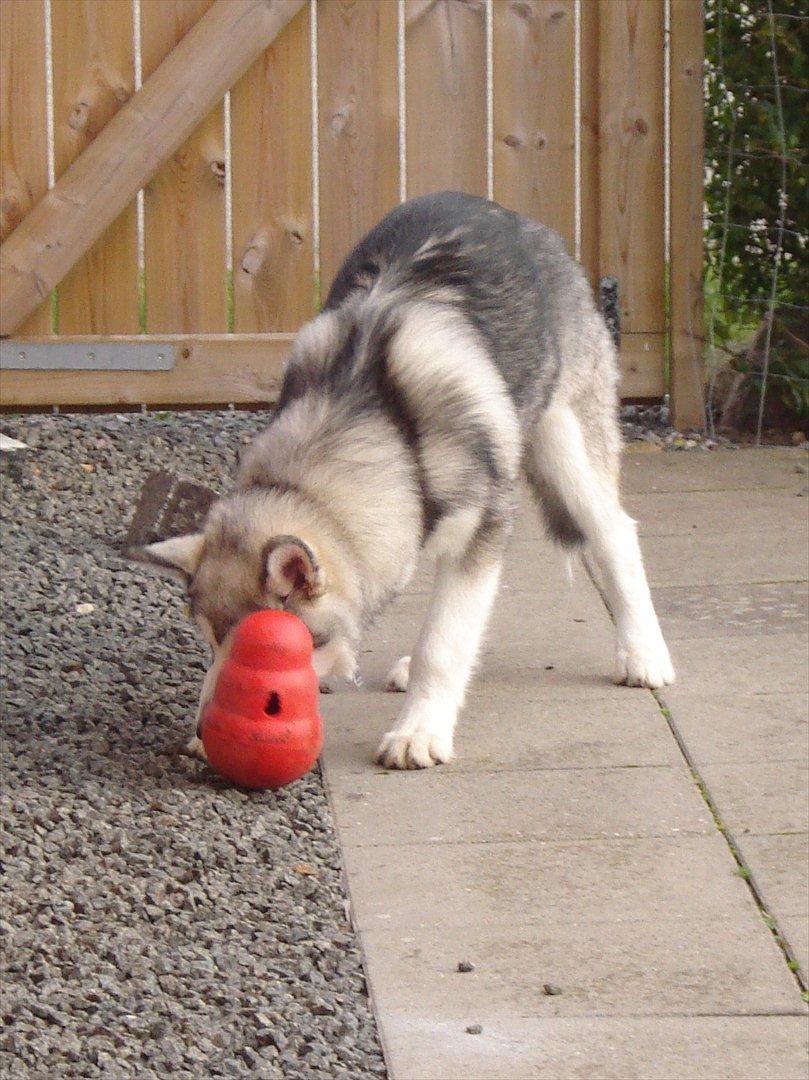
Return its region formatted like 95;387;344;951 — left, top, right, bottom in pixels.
377;557;500;769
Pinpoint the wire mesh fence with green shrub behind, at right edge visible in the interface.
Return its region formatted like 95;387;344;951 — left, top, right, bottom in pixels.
704;0;809;443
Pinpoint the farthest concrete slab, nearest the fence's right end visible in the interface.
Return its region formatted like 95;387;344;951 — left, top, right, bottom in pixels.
621;445;807;492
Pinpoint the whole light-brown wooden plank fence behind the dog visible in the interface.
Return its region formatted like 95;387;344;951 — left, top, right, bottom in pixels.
0;0;702;423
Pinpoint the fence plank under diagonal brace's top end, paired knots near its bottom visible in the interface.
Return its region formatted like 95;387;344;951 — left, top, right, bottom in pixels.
230;6;314;333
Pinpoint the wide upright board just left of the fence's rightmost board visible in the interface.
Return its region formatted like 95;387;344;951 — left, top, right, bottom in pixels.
598;0;664;334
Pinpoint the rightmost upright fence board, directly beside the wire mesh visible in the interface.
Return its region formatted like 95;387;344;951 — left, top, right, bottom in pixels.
670;0;705;429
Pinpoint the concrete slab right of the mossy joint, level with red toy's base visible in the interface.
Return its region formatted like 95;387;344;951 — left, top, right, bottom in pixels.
701;761;809;833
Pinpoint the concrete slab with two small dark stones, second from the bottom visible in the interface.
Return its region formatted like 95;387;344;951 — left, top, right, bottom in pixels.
363;916;803;1023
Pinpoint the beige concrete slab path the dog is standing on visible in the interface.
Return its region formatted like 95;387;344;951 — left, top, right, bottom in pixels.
324;449;809;1080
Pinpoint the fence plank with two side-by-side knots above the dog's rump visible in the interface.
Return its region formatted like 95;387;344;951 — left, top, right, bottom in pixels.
493;0;576;252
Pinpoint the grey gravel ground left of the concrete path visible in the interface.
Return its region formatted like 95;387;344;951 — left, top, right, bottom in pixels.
0;413;385;1080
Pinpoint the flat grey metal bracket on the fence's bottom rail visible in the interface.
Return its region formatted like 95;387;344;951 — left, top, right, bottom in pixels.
0;338;175;372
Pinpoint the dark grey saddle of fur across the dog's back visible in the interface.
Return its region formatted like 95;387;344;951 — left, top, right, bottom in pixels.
325;191;603;422
